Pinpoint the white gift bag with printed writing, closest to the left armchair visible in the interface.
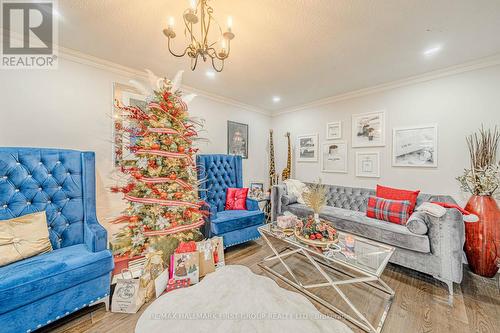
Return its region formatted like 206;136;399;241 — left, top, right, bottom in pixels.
111;270;145;313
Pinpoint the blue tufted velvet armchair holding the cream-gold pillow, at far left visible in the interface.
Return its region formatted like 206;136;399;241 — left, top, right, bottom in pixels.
0;148;113;332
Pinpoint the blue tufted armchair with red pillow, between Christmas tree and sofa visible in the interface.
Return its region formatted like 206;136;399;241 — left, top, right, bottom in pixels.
196;155;264;248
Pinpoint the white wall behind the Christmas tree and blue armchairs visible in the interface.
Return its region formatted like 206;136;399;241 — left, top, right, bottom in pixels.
0;56;271;231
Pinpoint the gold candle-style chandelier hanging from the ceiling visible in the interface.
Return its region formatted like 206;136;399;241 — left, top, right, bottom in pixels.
163;0;234;72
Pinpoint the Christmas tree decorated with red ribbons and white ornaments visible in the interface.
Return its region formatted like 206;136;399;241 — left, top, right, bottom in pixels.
111;71;206;256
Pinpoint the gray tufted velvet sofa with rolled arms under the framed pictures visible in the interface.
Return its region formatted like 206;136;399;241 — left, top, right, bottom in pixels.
271;185;465;301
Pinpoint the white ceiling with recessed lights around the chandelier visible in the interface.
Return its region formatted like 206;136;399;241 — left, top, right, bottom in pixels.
59;0;500;111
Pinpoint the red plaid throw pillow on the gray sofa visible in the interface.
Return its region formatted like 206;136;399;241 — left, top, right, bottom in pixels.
366;196;411;225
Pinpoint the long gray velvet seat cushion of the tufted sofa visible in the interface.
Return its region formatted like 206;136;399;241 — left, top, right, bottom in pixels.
287;204;430;253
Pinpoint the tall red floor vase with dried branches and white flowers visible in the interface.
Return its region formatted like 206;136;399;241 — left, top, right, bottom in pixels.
457;127;500;278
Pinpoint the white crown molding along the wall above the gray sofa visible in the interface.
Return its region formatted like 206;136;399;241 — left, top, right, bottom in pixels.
271;54;500;117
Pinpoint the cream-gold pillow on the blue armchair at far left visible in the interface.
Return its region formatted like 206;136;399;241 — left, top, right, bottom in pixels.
0;211;52;267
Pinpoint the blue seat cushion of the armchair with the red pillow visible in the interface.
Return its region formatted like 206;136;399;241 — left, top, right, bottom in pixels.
211;210;264;235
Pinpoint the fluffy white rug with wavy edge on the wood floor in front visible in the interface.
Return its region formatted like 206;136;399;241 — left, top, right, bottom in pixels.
135;265;352;333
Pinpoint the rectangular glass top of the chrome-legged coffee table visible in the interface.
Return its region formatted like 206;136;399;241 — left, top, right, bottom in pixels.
259;223;394;277
